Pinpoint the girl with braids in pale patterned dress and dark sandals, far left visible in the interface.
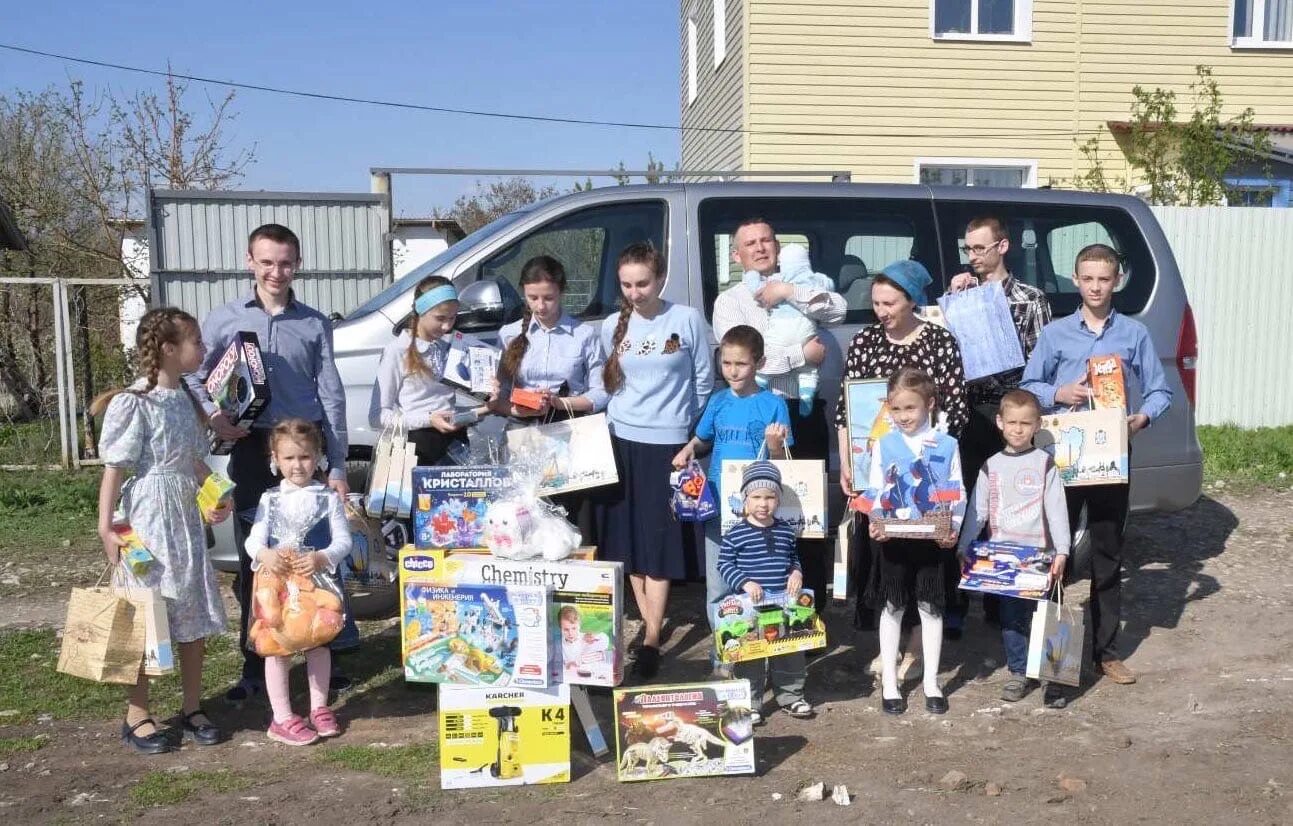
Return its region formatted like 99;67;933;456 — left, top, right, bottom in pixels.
91;308;231;754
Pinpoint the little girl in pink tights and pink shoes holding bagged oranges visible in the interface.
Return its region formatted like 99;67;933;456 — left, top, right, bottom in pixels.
246;419;350;746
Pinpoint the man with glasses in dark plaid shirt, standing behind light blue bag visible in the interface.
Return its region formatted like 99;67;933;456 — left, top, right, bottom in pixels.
943;216;1051;640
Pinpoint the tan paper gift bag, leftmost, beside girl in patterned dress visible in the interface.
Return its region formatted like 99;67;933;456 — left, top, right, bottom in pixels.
58;573;147;685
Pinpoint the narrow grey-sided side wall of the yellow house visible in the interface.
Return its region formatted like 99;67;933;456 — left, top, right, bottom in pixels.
679;0;745;169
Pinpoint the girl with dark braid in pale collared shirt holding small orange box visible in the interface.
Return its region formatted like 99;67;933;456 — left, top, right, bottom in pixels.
493;255;606;543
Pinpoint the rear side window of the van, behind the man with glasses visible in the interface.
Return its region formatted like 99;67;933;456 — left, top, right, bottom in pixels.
937;200;1157;317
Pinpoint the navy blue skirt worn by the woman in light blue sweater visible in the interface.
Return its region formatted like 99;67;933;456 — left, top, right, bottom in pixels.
593;436;705;579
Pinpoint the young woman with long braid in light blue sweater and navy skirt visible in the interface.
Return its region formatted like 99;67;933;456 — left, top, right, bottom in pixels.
597;243;714;680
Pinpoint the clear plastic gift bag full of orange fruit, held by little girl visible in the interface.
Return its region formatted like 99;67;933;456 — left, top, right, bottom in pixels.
247;487;345;657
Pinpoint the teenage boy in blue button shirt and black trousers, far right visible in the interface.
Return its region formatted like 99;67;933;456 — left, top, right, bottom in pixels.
1020;244;1171;685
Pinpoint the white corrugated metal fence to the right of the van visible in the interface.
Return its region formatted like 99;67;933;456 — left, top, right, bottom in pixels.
1153;207;1293;428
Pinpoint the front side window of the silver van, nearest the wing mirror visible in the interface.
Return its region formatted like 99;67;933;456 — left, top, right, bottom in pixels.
477;200;667;321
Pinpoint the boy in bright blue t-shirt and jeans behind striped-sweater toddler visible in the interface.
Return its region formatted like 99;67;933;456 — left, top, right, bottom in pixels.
674;324;794;680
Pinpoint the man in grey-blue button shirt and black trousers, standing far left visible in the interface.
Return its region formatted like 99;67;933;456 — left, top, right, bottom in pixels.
186;224;357;703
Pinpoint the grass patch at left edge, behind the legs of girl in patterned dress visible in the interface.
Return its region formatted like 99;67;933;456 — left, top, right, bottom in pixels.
0;628;242;725
